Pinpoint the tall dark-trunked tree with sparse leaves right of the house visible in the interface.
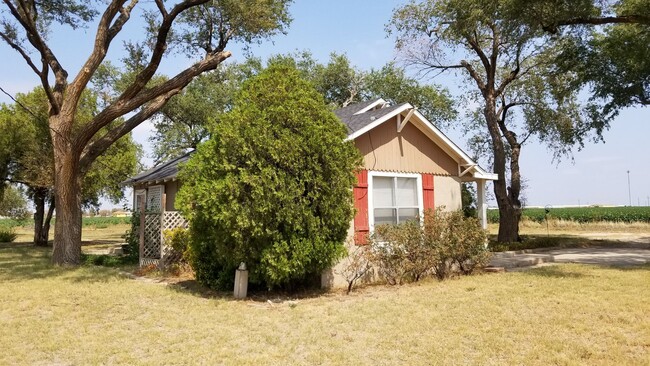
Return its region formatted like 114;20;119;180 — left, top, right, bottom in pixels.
388;0;607;242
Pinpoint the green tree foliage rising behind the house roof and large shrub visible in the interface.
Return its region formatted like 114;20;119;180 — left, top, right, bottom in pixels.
151;51;456;161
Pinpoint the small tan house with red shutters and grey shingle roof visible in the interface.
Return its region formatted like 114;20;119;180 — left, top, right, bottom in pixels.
124;98;497;278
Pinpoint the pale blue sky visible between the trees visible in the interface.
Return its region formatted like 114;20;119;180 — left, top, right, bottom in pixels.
0;0;650;206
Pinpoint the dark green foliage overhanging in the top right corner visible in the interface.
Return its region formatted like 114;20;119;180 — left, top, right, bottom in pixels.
515;0;650;114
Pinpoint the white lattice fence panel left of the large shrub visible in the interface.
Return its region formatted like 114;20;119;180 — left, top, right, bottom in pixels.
140;211;188;266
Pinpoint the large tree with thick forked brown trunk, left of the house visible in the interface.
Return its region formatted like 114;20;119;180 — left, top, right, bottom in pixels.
0;0;290;265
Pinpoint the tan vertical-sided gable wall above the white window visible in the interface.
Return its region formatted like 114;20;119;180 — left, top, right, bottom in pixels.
354;117;458;175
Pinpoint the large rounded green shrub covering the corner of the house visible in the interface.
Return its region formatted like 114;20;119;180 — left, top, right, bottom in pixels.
178;65;360;288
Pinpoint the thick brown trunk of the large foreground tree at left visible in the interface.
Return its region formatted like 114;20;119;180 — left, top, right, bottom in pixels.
50;116;81;265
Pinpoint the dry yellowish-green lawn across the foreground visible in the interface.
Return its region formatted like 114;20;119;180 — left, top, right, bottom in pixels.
0;245;650;365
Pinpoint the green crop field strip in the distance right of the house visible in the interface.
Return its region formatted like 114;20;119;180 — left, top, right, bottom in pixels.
488;207;650;223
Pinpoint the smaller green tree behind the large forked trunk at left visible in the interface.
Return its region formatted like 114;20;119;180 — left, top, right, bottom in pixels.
0;88;141;246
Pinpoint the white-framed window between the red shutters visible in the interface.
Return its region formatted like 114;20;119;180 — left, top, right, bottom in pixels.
368;172;422;228
